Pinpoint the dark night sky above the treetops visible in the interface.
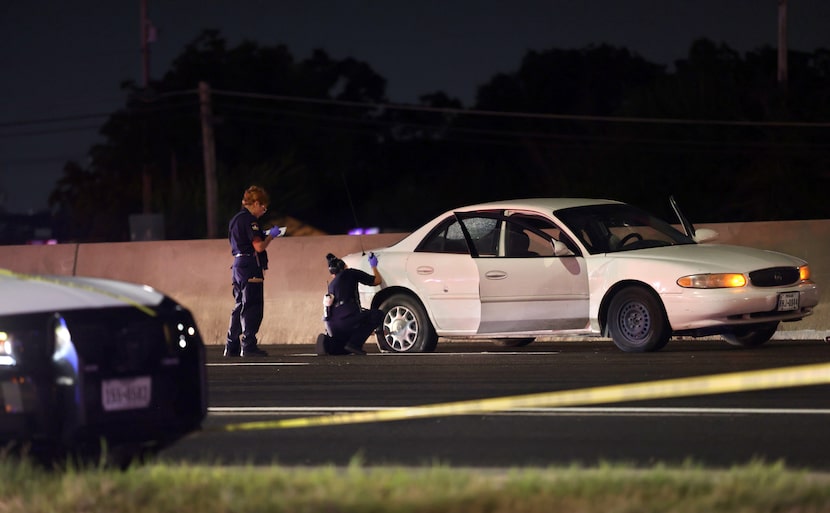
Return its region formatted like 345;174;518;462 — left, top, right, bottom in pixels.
0;0;830;213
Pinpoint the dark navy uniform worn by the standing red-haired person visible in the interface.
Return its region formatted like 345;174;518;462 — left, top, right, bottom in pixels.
225;207;266;356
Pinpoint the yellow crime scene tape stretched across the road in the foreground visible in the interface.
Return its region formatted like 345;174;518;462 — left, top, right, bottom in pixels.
220;363;830;431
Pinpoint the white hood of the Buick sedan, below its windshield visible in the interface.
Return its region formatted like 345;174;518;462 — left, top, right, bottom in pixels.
606;244;807;272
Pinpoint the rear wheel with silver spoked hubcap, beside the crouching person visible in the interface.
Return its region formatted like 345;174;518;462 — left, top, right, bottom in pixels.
377;294;438;353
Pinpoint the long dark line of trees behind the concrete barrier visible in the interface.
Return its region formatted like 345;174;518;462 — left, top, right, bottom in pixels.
49;31;830;241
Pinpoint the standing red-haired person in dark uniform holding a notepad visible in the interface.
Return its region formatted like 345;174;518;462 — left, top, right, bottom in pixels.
225;185;280;357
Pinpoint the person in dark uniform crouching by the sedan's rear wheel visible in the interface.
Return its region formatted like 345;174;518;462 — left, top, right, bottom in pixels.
317;253;383;354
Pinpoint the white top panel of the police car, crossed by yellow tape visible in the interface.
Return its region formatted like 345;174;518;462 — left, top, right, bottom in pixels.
0;269;164;315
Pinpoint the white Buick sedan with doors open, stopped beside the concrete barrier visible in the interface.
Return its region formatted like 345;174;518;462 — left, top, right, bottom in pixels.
344;198;819;352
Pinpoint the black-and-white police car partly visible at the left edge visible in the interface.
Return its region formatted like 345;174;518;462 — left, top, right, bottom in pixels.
0;269;207;465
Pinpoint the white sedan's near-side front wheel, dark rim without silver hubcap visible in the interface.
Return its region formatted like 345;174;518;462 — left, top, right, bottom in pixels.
608;287;671;353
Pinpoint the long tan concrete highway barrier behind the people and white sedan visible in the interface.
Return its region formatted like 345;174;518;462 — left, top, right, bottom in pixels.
0;220;830;344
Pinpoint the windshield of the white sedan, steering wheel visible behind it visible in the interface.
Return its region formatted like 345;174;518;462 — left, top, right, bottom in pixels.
554;204;695;254
